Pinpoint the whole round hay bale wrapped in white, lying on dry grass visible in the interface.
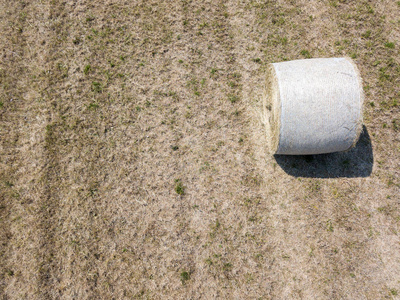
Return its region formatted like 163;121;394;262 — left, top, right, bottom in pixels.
264;58;364;155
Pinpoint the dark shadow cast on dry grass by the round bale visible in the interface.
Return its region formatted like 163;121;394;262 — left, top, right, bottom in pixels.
274;126;374;178
